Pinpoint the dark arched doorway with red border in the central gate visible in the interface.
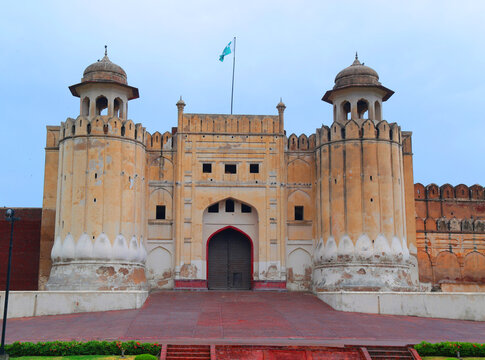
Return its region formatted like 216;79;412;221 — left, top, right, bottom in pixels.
207;226;253;290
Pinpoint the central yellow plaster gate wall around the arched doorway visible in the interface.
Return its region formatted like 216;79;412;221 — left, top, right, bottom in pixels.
169;102;286;281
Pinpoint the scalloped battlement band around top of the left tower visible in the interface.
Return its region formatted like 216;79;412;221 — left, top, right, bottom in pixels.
59;115;147;144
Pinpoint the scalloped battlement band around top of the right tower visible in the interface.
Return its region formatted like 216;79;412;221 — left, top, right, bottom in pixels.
316;120;402;147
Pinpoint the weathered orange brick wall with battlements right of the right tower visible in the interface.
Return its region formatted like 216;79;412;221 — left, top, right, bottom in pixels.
414;183;485;291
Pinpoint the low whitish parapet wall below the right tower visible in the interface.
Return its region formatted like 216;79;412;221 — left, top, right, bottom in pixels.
317;291;485;321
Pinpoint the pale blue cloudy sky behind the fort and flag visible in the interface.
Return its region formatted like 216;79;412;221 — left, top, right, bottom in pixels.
0;0;485;207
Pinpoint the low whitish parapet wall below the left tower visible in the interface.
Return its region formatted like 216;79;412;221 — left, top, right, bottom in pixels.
0;291;148;319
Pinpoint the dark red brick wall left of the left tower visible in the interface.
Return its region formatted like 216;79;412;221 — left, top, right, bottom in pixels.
0;208;42;291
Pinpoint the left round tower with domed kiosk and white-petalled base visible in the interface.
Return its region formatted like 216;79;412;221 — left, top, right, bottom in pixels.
46;51;146;290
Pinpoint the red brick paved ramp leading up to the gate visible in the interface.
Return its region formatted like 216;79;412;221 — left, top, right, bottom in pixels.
3;291;485;345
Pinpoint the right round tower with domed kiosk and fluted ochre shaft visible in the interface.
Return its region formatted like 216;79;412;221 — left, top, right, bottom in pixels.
313;55;416;291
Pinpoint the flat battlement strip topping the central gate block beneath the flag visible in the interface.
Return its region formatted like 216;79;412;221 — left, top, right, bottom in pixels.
179;114;284;135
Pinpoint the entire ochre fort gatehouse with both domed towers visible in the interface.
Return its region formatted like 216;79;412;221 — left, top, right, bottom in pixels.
39;52;418;291
